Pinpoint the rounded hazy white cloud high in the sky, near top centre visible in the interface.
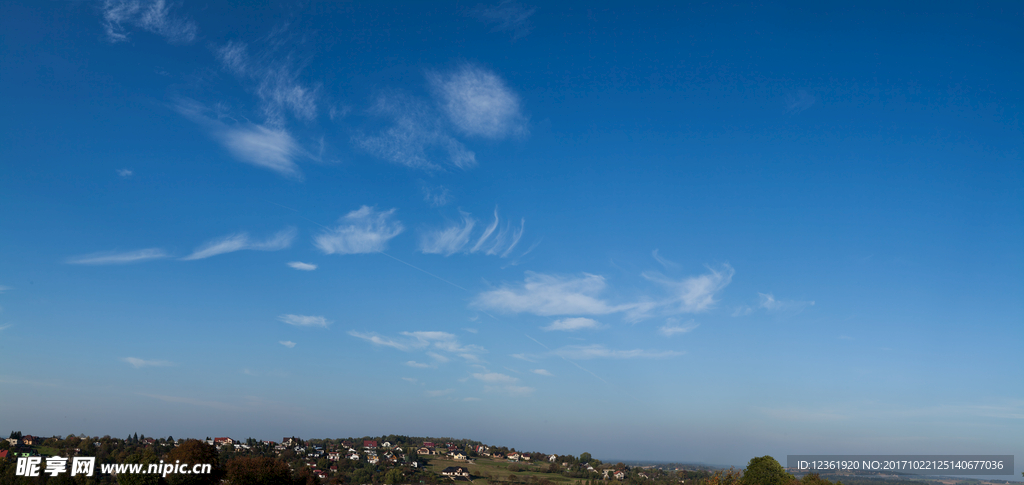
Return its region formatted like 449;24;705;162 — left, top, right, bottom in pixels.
428;65;526;139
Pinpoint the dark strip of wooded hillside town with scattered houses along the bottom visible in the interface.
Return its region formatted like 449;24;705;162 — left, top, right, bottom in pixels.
0;431;1009;485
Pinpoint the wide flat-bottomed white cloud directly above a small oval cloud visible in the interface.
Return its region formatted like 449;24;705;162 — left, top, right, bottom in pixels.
473;271;629;316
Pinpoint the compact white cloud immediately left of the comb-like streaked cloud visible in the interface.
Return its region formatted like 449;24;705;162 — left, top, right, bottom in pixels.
313;206;404;255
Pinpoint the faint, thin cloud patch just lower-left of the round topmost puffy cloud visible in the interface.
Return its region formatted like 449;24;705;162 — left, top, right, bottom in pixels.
352;94;476;170
